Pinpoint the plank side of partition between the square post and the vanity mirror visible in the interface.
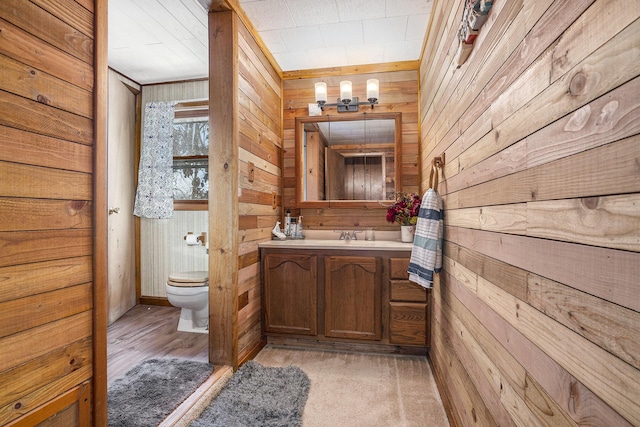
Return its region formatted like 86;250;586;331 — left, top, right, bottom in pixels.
238;16;282;363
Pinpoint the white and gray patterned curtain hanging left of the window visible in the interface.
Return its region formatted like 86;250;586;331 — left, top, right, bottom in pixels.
133;102;175;218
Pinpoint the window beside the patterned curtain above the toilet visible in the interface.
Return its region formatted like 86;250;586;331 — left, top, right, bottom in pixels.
173;107;209;210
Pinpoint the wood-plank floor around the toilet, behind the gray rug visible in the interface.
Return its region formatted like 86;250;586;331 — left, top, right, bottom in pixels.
107;305;209;382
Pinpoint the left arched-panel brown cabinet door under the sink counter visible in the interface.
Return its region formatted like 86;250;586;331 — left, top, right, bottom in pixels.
263;254;318;335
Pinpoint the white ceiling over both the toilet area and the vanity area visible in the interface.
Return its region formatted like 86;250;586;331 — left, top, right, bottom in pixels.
109;0;433;84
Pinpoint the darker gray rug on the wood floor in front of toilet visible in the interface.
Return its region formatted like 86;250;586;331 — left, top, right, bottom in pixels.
107;358;213;427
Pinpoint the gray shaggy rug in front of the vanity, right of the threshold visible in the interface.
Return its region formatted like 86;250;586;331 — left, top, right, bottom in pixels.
190;361;310;427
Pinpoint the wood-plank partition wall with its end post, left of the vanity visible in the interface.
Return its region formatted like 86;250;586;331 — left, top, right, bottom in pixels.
209;11;282;367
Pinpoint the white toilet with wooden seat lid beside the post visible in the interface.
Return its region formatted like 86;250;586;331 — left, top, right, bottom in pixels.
166;271;209;334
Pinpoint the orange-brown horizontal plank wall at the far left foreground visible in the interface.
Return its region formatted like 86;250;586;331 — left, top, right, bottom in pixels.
0;0;96;425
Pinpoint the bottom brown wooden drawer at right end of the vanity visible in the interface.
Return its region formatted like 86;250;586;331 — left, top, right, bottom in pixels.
389;302;427;346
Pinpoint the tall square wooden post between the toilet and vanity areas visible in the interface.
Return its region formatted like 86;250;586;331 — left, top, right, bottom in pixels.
209;11;239;369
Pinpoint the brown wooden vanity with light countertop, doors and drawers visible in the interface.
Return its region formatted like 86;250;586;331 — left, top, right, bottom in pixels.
260;240;431;354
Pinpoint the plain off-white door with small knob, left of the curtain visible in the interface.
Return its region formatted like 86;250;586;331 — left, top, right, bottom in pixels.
107;70;136;324
